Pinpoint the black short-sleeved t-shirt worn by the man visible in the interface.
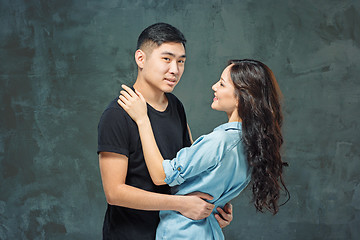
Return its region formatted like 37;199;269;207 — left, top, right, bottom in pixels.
98;93;191;240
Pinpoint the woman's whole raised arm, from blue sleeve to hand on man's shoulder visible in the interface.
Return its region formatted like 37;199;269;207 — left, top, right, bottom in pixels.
119;85;226;186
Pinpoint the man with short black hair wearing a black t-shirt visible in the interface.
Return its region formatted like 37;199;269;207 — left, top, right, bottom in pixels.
98;23;232;239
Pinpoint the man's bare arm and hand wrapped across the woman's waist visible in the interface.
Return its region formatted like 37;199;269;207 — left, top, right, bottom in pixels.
99;152;214;220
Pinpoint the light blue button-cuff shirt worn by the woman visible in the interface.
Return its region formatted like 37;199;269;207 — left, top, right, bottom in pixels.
156;122;251;240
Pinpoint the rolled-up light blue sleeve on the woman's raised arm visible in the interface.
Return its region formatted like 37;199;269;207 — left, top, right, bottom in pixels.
163;132;236;186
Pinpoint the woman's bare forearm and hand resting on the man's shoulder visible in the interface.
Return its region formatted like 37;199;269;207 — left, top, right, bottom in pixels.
118;85;166;185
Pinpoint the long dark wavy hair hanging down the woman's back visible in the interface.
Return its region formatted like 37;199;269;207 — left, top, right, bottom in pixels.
229;59;290;215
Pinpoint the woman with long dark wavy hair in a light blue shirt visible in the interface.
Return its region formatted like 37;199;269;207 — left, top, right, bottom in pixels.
118;60;288;239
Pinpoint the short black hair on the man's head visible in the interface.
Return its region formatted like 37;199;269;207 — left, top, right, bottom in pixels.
136;23;186;49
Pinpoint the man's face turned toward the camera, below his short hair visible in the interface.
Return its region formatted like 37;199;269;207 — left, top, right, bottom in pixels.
142;42;186;92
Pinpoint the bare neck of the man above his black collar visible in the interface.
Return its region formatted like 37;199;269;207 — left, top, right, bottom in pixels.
133;77;168;112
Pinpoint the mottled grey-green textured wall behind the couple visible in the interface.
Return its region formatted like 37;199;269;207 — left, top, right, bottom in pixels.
0;0;360;240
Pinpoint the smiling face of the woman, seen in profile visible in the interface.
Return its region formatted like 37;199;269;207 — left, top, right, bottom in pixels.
211;65;238;115
